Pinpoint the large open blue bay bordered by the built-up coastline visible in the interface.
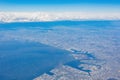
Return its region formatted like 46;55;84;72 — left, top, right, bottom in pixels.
0;41;73;80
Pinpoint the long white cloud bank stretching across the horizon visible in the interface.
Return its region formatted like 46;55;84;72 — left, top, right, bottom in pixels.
0;12;120;22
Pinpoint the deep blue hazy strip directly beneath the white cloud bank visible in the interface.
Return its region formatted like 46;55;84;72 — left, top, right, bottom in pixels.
0;20;119;29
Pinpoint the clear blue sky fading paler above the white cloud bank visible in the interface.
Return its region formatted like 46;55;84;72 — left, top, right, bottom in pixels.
0;0;120;12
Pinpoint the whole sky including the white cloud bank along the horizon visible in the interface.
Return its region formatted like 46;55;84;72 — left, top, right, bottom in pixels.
0;0;120;22
